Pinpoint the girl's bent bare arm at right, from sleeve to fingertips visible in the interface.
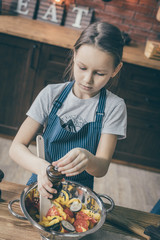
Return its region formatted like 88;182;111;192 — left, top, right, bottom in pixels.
52;134;117;177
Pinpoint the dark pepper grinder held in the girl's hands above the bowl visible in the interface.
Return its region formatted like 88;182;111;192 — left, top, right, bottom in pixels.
46;165;65;200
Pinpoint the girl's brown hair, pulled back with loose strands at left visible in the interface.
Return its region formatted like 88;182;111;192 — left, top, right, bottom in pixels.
64;22;124;81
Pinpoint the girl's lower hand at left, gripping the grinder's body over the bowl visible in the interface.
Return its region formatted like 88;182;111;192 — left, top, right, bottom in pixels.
37;162;57;198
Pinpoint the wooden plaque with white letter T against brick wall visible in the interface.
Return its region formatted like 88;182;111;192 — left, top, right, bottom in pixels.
65;4;93;30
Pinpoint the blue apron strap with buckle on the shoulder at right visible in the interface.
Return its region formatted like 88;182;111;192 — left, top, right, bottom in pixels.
96;88;106;124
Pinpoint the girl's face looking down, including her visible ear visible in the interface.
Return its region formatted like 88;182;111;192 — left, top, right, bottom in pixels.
73;44;122;99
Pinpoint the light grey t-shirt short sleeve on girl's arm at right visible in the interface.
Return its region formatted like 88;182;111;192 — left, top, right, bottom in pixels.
102;99;127;140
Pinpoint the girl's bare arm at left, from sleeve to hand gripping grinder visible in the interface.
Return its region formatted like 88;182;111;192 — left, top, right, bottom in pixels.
9;117;55;197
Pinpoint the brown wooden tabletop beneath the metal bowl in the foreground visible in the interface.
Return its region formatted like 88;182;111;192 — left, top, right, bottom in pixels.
0;181;160;240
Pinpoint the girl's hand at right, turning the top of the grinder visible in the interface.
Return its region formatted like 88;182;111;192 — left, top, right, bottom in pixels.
52;148;91;177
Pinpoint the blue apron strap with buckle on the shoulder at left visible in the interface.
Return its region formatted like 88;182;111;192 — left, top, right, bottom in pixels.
50;81;74;117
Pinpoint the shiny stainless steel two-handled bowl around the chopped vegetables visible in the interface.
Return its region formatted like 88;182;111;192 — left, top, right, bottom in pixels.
8;181;114;240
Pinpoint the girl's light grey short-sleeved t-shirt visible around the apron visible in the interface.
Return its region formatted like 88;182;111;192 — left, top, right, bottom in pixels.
27;82;127;139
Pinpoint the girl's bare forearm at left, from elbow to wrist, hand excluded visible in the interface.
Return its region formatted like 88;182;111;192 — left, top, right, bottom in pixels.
9;142;49;174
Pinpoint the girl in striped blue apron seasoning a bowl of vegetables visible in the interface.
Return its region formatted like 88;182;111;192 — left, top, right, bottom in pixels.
10;22;127;198
